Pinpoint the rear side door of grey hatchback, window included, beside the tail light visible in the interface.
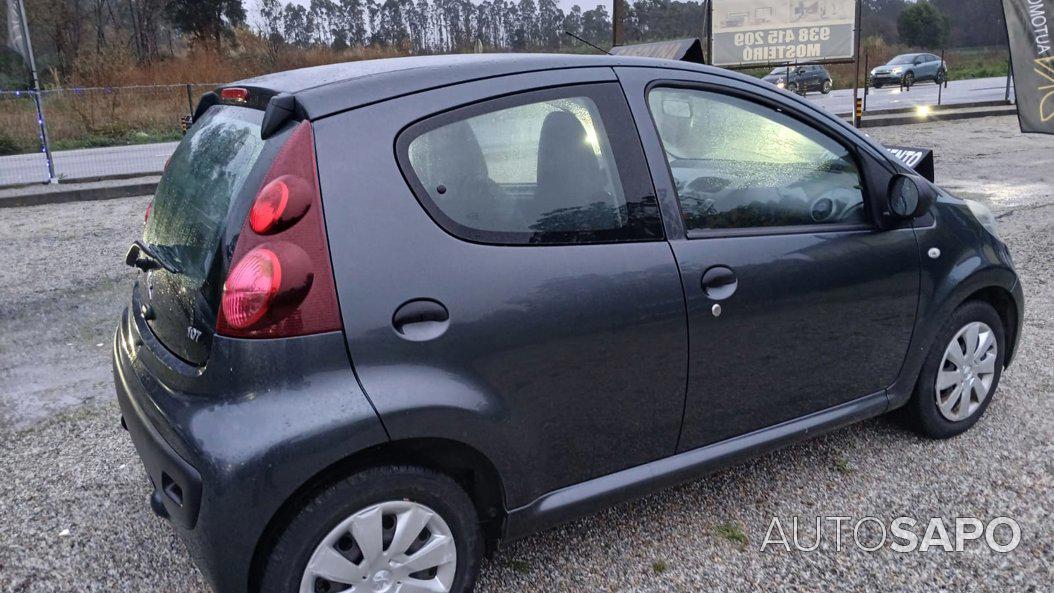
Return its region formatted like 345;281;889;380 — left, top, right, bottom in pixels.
316;68;687;507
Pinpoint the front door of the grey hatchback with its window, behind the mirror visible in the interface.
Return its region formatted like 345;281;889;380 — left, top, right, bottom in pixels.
618;68;919;450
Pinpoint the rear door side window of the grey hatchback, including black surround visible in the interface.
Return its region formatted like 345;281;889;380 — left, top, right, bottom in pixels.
398;84;662;244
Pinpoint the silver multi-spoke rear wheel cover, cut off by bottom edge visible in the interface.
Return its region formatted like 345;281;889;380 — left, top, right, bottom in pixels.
300;500;457;593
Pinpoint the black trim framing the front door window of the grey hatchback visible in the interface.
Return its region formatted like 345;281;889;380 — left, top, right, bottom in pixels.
644;79;876;239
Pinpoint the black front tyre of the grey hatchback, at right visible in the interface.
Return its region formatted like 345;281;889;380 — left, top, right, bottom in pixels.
904;300;1007;439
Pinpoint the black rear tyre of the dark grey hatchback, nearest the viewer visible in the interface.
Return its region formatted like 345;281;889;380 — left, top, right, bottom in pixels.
259;466;483;593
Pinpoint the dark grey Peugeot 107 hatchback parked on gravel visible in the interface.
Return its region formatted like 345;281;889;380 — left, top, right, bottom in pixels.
114;55;1023;593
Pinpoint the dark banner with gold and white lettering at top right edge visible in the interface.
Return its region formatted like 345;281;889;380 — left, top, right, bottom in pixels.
1002;0;1054;134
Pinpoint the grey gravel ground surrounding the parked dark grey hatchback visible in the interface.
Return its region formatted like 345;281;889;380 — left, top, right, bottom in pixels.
0;118;1054;593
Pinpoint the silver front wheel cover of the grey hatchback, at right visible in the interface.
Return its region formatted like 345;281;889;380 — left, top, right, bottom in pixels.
934;321;999;422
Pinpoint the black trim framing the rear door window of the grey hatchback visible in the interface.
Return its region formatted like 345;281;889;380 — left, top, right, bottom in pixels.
394;81;666;246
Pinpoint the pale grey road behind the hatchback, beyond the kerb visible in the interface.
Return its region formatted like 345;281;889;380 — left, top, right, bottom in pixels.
0;78;1013;185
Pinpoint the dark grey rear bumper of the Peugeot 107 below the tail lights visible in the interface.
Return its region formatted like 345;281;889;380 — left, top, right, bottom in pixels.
113;286;387;593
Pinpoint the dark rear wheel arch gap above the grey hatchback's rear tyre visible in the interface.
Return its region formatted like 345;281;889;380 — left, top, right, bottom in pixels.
249;438;506;592
